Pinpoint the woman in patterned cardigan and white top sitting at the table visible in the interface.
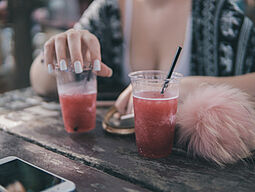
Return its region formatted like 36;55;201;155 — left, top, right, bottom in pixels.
31;0;255;113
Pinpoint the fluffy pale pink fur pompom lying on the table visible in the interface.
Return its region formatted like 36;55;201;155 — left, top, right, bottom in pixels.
177;85;255;166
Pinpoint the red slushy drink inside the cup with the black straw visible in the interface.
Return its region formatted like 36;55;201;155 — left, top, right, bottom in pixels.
134;91;178;158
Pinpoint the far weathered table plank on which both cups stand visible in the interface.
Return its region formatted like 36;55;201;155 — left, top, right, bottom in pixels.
0;89;255;191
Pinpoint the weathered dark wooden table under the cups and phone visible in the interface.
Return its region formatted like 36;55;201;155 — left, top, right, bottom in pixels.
0;88;255;192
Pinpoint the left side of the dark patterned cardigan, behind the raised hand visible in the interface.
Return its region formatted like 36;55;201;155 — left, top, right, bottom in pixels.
74;0;126;99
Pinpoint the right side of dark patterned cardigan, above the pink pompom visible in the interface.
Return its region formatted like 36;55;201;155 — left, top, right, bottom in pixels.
191;0;255;76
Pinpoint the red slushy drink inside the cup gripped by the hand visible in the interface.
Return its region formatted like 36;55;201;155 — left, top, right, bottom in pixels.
59;93;97;133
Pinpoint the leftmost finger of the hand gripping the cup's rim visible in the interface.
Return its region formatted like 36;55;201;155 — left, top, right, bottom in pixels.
43;38;55;73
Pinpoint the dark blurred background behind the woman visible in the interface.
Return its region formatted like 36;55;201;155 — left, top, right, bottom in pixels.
0;0;255;93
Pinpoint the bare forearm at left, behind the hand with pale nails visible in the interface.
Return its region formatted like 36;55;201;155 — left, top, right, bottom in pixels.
30;54;57;97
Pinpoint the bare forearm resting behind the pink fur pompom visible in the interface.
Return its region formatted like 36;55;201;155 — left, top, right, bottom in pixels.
180;73;255;100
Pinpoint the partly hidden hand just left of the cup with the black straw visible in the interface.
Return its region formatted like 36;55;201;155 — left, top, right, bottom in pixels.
115;85;134;115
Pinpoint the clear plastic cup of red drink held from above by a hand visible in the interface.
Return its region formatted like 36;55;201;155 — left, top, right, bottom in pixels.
57;70;97;133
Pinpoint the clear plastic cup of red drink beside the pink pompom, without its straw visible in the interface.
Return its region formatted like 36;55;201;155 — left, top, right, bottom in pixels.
129;70;182;158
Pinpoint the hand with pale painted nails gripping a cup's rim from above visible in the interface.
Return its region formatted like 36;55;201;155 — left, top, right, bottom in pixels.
44;29;112;77
